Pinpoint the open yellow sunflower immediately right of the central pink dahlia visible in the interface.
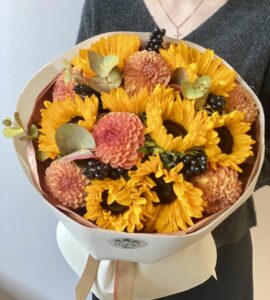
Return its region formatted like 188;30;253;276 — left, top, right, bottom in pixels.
146;94;215;152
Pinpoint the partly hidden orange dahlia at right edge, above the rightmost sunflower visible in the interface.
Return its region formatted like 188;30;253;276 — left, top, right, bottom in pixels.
226;84;258;123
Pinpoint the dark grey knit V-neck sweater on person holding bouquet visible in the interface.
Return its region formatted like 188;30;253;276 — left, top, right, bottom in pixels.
77;0;270;246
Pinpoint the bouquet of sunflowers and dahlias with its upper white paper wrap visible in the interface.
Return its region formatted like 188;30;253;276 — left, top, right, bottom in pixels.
4;29;263;298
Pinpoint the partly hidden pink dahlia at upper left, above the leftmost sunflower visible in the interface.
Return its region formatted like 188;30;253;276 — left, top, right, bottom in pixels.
52;73;75;101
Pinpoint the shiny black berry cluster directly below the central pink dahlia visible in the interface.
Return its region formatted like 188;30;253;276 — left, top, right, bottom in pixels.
82;158;126;180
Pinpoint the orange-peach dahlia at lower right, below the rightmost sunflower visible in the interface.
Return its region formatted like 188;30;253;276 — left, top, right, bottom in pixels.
193;167;242;214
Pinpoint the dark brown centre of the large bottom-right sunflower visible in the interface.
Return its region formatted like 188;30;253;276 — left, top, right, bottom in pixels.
149;174;177;204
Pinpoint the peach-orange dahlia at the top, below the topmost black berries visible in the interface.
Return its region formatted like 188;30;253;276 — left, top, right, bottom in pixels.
124;51;171;94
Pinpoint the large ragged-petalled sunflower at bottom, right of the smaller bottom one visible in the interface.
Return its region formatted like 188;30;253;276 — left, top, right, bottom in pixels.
129;155;205;232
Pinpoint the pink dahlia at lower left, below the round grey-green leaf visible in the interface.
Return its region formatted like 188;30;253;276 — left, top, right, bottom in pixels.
45;160;88;209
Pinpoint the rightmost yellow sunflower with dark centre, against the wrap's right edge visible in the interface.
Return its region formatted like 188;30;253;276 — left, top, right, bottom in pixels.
206;111;255;172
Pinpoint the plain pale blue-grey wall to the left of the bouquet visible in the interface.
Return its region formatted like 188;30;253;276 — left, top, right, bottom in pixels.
0;0;83;300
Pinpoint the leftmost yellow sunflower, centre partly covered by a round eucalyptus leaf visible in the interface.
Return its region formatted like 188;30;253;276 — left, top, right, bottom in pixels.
38;95;98;159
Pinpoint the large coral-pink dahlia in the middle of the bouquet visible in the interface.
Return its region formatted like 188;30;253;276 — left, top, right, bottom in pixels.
93;112;144;169
